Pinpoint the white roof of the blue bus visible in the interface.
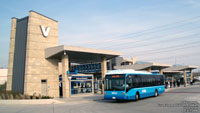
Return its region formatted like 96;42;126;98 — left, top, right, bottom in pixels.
106;69;152;75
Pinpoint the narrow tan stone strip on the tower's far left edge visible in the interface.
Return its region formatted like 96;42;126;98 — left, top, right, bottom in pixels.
6;18;17;91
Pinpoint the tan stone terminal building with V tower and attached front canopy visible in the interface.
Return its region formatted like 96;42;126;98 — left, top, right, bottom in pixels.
7;11;120;97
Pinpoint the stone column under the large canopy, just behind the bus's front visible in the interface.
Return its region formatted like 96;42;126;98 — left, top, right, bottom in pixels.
101;58;107;94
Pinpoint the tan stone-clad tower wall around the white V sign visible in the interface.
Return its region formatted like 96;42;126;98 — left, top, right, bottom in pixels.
24;11;59;97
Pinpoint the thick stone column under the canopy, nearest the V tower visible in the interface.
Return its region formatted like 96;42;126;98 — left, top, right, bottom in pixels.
62;55;71;97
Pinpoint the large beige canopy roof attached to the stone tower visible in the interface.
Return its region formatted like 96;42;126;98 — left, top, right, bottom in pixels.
45;45;120;63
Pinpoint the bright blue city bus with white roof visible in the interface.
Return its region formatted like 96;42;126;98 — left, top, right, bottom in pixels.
104;70;165;100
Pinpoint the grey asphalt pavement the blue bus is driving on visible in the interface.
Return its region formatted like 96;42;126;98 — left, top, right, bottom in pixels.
0;85;200;113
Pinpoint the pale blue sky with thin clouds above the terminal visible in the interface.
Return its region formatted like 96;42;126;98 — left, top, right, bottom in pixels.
0;0;200;70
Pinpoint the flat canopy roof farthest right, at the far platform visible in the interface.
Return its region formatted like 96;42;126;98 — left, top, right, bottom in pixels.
163;66;198;71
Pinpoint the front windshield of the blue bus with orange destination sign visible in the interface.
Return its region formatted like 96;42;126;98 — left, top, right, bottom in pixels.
104;74;125;91
